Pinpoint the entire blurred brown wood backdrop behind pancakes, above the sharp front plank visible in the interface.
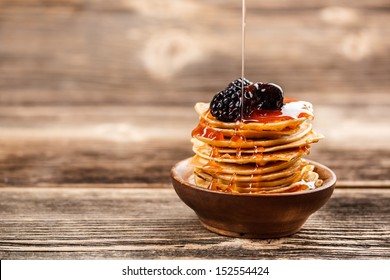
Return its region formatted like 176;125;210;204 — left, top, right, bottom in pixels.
0;0;390;185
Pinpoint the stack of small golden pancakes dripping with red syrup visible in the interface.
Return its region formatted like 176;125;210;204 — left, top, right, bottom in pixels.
191;101;323;193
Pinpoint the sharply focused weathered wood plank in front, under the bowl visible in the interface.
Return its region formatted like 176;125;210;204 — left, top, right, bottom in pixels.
0;188;390;259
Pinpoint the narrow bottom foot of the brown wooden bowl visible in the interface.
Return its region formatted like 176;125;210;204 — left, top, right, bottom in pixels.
199;219;302;239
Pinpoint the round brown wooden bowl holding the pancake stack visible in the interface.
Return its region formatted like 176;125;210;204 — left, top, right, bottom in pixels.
171;159;336;238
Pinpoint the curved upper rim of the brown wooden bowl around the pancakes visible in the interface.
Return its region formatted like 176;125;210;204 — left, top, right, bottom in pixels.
171;157;337;197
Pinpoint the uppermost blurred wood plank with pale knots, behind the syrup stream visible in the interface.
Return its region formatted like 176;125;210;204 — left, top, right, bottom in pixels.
0;1;390;106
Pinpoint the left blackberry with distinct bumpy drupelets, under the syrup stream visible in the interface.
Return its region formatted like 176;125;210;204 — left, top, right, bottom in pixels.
210;79;256;122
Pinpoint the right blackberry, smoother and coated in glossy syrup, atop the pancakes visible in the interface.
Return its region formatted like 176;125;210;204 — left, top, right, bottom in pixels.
255;83;283;110
